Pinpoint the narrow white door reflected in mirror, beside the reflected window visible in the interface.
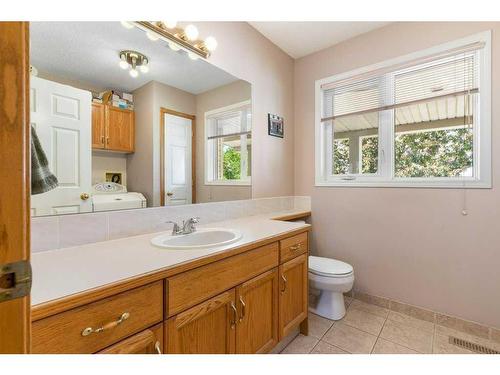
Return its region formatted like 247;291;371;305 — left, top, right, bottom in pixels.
163;114;193;206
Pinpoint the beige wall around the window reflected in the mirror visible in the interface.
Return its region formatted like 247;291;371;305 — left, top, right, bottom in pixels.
196;80;252;203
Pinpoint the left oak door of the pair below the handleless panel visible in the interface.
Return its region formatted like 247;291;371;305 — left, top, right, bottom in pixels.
165;289;238;354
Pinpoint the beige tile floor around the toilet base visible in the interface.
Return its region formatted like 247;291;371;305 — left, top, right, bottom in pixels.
281;297;500;354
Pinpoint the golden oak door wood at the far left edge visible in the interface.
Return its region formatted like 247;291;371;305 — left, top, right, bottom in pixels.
0;22;31;354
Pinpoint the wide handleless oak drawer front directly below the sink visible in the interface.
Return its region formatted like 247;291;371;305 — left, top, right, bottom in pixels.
167;242;279;316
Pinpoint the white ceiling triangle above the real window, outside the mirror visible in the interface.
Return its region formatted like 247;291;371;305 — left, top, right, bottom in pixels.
249;22;389;59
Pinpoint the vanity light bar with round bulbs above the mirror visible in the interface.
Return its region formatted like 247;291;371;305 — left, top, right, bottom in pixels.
134;21;217;59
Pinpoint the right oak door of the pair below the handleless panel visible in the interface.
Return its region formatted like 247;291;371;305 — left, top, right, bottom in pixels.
236;268;278;354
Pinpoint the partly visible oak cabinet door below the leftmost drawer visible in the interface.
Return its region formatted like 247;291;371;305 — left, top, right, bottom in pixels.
97;324;163;354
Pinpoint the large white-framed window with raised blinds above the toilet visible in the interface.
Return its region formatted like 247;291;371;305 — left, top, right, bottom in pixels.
316;32;491;188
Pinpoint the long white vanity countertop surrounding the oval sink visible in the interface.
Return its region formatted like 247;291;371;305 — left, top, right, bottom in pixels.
31;210;309;306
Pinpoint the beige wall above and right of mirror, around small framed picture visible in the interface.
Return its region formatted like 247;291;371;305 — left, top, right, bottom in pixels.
196;22;294;198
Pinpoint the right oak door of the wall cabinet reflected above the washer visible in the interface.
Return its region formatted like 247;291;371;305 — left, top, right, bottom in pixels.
106;106;135;152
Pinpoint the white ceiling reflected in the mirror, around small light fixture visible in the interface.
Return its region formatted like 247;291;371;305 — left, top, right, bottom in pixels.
30;22;238;94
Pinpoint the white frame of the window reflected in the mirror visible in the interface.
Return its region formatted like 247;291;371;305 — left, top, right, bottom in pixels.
204;100;253;186
